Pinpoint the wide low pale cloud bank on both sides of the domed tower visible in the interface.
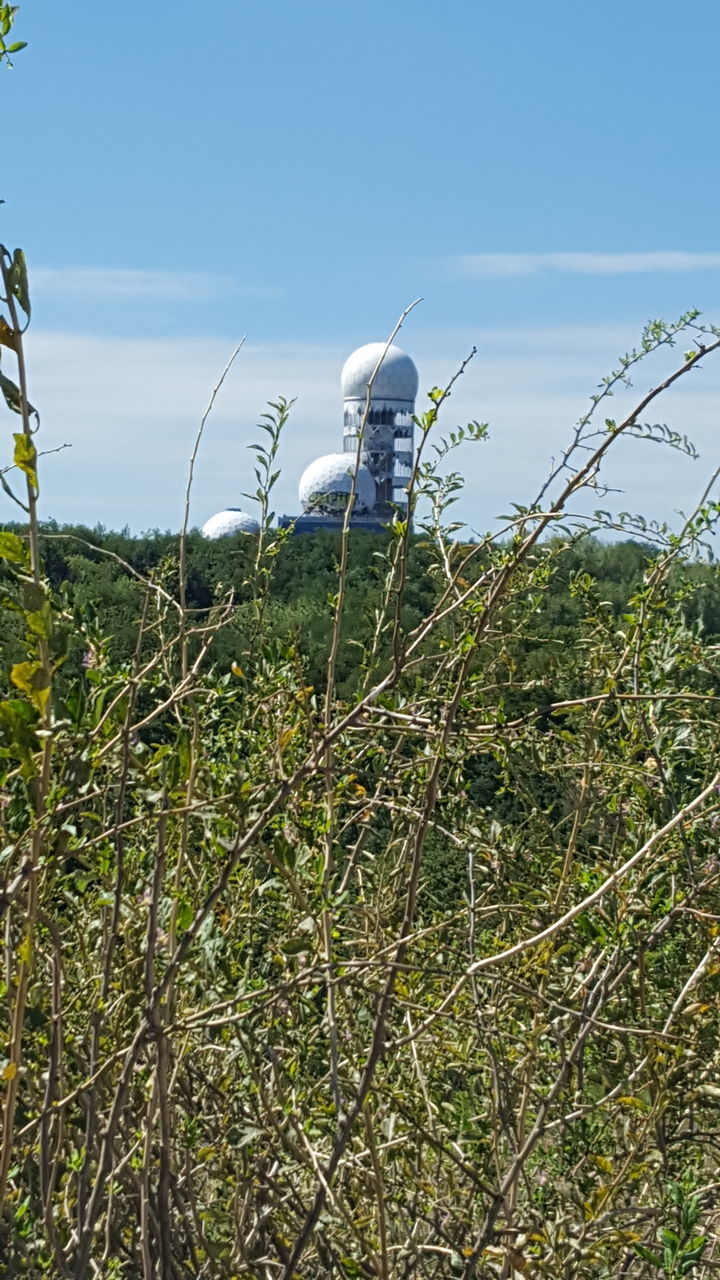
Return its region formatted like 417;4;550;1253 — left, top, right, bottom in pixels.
0;325;720;531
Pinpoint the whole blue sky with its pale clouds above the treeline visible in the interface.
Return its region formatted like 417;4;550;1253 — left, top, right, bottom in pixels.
0;0;720;531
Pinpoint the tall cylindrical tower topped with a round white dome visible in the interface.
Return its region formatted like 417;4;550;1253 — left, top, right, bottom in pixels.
341;342;418;520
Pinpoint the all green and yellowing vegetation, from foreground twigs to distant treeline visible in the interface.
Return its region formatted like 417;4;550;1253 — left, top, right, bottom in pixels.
0;24;720;1280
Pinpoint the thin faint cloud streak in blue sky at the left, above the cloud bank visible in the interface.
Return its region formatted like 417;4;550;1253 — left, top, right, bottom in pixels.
32;266;277;302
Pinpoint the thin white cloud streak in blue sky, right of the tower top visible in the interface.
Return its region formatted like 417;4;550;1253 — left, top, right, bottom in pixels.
446;252;720;276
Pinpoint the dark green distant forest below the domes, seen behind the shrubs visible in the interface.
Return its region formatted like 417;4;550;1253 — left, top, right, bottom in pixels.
0;524;720;700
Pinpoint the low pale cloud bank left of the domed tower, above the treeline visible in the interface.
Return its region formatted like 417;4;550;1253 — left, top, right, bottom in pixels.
13;330;346;530
